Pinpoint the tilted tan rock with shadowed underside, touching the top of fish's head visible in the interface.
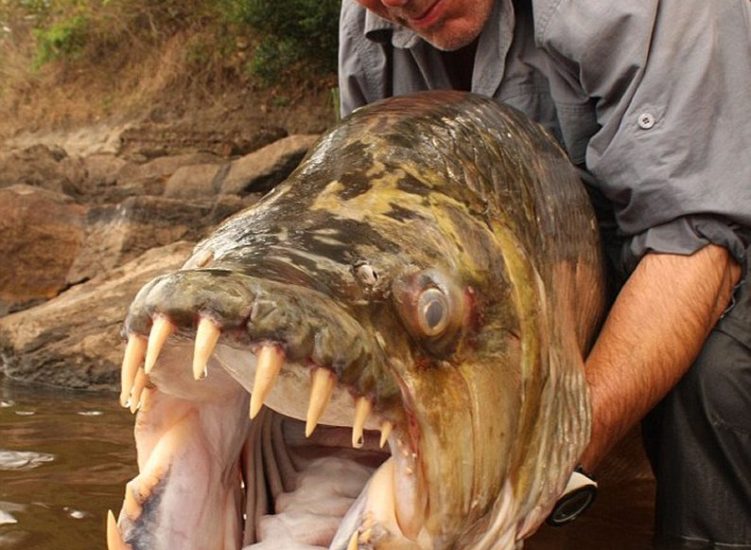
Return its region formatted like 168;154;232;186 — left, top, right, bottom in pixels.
221;134;318;196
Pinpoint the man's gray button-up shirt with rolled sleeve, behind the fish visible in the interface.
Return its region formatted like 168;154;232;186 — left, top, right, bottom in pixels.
339;0;751;270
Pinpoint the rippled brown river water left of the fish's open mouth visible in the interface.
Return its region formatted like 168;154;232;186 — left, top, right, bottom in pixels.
0;376;136;550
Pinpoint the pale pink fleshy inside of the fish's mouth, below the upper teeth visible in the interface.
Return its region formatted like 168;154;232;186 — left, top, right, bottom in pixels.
113;345;414;550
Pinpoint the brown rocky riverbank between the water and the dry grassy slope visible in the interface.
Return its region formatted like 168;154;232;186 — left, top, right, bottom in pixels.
0;125;318;389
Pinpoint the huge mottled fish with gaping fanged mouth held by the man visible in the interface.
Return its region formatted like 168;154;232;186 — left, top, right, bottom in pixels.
107;91;604;550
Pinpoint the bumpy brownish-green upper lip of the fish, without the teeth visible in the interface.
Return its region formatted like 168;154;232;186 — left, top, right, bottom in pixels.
123;269;384;386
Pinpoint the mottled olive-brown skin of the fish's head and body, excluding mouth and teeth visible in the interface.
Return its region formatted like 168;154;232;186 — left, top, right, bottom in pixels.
113;92;604;549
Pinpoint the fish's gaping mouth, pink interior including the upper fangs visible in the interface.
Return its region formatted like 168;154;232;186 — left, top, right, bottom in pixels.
108;272;426;550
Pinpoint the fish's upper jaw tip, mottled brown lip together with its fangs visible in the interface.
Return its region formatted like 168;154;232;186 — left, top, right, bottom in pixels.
120;269;400;442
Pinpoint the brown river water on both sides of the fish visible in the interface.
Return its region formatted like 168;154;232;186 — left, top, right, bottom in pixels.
0;376;653;550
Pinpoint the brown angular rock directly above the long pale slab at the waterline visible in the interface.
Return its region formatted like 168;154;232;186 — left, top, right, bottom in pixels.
67;196;218;284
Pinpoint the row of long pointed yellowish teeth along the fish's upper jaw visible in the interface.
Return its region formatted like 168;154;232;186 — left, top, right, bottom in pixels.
120;314;394;448
